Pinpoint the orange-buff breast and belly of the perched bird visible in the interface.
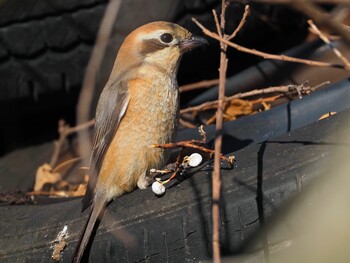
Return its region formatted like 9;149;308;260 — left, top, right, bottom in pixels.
96;69;178;199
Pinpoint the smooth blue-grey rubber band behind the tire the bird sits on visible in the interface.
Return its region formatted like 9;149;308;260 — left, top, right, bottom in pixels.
177;79;350;154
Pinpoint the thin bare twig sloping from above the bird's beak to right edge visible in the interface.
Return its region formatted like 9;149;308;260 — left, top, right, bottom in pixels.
192;18;350;70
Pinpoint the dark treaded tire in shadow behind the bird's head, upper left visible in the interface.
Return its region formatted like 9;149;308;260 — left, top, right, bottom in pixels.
0;0;218;101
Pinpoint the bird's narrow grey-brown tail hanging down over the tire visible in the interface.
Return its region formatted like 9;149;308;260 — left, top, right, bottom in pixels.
72;200;106;263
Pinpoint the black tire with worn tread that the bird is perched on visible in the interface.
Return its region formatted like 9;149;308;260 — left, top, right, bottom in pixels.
0;108;350;263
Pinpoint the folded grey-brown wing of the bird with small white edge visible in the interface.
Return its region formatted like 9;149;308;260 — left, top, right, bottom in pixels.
83;79;129;211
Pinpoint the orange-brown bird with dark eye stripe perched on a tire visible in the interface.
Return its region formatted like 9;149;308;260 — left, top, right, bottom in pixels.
72;21;208;263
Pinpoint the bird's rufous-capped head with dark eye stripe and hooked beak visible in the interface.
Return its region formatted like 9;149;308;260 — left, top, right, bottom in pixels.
114;21;208;77
